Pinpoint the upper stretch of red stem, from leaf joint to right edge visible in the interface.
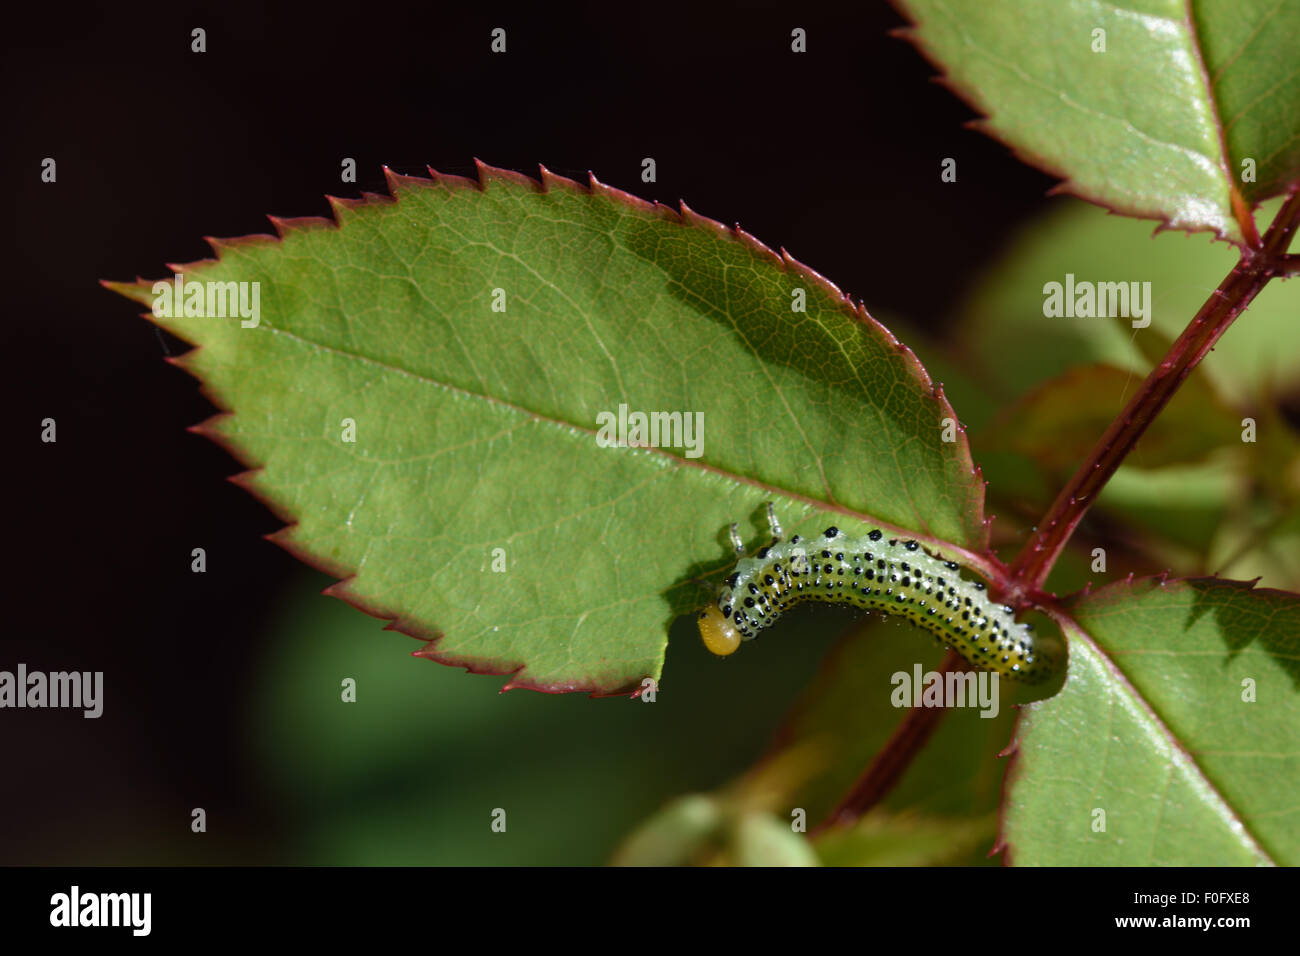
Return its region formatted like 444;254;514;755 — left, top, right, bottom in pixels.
1002;190;1300;605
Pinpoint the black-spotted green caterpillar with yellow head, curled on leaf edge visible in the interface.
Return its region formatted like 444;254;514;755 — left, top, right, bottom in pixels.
698;502;1056;683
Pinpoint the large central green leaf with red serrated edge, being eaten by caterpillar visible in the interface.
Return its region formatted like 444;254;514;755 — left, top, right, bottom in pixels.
111;166;985;693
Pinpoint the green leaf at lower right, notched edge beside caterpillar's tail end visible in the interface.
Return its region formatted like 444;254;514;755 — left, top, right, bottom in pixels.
1004;579;1300;866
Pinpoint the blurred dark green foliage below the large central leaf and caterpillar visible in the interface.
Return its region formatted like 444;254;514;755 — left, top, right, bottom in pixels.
248;574;848;865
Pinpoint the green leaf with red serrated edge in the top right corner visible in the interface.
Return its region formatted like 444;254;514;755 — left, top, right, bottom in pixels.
901;0;1300;243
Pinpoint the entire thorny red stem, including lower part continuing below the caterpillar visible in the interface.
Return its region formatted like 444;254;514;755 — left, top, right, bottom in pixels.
814;187;1300;832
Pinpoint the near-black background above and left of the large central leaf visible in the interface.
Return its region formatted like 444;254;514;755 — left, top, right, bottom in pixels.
0;3;1052;864
